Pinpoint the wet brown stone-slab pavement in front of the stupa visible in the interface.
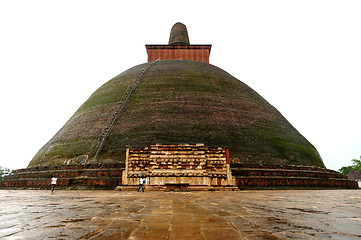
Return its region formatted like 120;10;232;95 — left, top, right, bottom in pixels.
0;190;361;240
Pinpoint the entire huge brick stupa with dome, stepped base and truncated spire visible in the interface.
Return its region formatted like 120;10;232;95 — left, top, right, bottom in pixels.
2;23;357;190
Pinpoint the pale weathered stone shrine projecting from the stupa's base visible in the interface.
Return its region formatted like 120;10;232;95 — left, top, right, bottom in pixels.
118;144;238;191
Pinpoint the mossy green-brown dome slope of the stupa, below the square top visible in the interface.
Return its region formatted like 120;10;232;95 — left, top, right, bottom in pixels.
29;60;324;167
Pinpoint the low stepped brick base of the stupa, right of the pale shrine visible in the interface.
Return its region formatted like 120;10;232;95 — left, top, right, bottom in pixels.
231;164;358;189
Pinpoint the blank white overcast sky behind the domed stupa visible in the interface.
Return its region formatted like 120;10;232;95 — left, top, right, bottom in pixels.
0;0;361;170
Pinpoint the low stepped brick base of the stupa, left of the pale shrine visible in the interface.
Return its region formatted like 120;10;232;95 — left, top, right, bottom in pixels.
0;164;124;189
